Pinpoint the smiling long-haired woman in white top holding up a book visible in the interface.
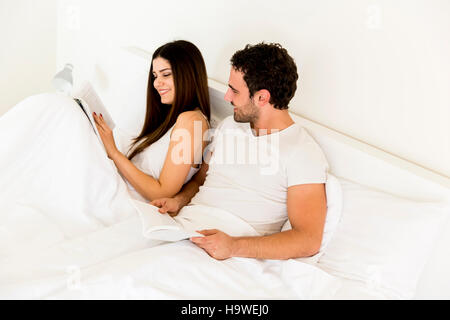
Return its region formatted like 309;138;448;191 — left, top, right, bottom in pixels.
94;40;210;201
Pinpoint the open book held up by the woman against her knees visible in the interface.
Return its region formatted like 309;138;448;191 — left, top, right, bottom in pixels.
72;81;116;145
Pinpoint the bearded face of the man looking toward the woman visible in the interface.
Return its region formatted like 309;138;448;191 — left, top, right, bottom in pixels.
225;67;259;123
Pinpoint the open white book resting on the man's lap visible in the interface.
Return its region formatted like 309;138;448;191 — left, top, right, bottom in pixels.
130;199;203;242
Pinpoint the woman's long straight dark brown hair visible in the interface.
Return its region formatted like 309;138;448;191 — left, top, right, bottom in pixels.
128;40;211;160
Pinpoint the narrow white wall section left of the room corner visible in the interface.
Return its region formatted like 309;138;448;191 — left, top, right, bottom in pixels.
0;0;57;116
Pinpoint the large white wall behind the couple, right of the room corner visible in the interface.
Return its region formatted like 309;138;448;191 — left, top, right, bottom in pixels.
57;0;450;176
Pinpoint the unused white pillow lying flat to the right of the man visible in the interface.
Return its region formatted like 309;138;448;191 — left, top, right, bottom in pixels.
317;178;450;299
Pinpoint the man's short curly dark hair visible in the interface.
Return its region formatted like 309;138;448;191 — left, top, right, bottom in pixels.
231;42;298;109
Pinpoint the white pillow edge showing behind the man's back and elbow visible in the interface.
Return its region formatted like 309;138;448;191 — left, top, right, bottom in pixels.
281;173;342;263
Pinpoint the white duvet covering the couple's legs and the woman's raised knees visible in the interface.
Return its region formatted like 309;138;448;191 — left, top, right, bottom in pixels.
0;94;372;299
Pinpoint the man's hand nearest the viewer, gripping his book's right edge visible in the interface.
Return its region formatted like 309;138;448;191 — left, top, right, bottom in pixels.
191;229;235;260
